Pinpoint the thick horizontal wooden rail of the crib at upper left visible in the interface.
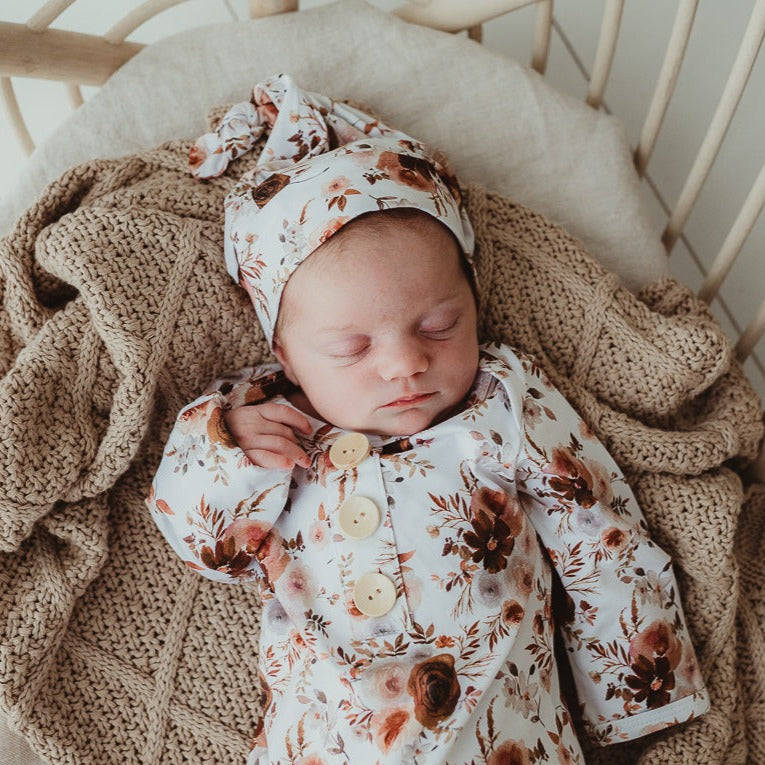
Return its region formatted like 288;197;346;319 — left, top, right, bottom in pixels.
0;21;144;85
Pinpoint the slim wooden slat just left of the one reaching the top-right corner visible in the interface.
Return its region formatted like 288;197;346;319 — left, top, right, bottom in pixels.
635;0;699;176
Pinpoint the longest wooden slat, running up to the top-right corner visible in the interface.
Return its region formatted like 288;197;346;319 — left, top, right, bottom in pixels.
661;0;765;253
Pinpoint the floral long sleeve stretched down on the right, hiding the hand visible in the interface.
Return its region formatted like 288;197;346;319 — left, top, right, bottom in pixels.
484;347;709;744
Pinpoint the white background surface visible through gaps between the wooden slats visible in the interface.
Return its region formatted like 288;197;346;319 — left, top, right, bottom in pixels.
0;0;765;395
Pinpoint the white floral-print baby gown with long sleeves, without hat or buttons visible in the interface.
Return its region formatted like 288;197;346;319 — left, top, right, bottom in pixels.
147;344;709;765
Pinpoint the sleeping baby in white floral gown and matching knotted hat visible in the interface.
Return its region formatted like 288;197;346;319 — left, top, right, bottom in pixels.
147;75;709;765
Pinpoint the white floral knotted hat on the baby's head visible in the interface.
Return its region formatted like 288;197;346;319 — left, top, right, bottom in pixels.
189;74;474;345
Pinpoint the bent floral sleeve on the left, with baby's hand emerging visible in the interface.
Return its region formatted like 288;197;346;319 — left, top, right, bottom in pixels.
146;366;291;582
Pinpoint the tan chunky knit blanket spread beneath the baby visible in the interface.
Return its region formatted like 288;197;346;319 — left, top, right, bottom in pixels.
0;133;765;765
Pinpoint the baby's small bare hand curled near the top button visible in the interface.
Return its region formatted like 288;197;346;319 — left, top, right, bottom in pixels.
223;402;311;468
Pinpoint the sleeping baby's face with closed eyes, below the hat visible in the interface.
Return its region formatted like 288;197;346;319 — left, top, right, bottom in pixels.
275;215;478;436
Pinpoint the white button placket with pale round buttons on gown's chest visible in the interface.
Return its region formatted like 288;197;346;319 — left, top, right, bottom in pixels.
330;434;411;639
